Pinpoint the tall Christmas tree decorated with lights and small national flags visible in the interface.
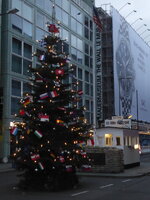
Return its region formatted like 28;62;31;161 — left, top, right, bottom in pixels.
10;24;91;189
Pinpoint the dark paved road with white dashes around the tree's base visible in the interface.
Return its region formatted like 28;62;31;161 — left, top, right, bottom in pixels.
0;172;150;200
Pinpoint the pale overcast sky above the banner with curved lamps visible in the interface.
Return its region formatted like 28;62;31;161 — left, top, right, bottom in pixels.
95;0;150;40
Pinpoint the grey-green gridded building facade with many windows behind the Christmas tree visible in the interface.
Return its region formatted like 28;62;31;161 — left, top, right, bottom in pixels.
0;0;95;158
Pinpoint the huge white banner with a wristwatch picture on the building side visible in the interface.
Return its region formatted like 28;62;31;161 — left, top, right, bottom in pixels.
112;8;150;122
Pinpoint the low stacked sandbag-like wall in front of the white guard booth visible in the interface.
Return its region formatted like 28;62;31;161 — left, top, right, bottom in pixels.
85;147;124;173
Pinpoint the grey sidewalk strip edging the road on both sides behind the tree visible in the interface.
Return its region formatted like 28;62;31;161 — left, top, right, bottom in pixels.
0;162;150;178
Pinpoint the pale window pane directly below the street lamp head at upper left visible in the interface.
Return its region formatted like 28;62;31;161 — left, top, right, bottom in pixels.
11;15;23;33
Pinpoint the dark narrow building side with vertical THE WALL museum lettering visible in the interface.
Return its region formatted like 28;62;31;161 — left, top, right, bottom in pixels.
96;8;115;126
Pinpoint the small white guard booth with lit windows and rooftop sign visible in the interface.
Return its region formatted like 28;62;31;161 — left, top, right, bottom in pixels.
95;116;140;167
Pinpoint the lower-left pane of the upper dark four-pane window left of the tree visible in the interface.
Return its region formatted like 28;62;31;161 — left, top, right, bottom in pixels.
12;55;22;74
